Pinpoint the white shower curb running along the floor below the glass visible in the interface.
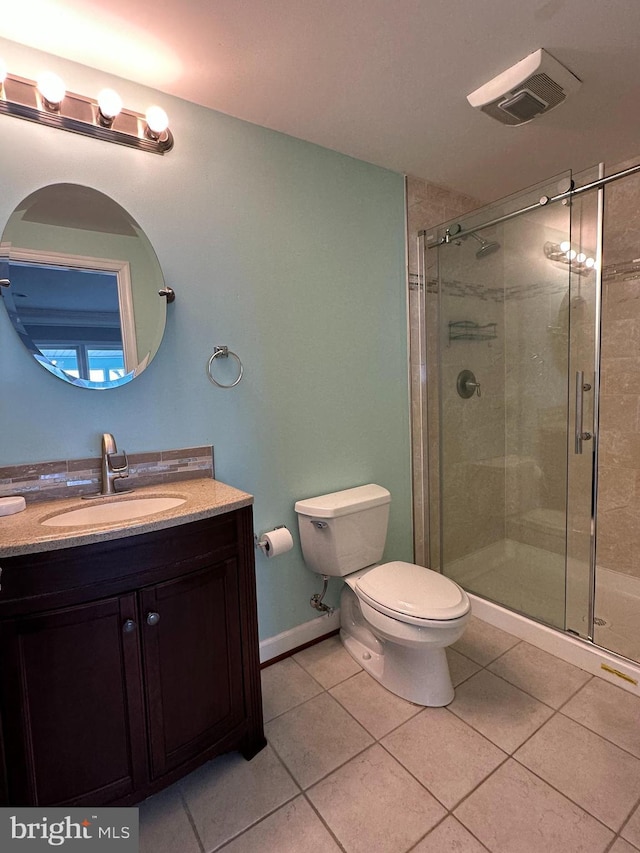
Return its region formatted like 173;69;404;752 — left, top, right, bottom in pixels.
468;593;640;696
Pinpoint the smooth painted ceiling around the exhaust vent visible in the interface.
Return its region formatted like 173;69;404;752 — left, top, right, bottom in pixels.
5;0;640;201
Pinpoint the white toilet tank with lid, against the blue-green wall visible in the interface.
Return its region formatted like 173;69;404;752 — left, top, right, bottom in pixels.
295;483;391;577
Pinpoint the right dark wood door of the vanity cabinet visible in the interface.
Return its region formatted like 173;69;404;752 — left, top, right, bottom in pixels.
140;558;245;778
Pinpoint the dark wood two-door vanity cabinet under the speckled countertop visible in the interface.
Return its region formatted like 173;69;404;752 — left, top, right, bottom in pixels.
0;507;265;805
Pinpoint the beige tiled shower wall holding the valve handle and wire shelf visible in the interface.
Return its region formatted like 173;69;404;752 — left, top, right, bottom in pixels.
426;226;506;570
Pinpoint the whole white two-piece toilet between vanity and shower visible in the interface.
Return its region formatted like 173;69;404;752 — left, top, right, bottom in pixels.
295;484;471;707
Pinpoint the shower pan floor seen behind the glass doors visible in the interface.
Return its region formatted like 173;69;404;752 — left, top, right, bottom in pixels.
445;539;640;661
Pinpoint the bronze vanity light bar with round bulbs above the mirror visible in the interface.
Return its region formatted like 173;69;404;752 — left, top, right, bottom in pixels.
0;59;173;154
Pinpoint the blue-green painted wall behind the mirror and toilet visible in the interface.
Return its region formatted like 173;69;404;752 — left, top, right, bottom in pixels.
0;40;412;638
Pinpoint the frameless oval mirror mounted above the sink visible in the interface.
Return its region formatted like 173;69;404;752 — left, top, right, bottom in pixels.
0;184;172;389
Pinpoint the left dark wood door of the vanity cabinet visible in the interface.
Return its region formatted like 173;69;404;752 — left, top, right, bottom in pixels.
0;594;147;805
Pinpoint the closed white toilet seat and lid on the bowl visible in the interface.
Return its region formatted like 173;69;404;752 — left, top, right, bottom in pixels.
353;560;470;626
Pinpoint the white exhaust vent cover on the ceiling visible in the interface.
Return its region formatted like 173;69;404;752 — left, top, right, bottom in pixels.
467;48;580;126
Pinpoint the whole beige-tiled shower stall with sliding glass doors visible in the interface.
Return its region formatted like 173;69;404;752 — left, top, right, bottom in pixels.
410;158;640;662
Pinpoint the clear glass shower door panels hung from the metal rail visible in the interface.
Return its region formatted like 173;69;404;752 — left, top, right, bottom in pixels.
426;175;595;635
